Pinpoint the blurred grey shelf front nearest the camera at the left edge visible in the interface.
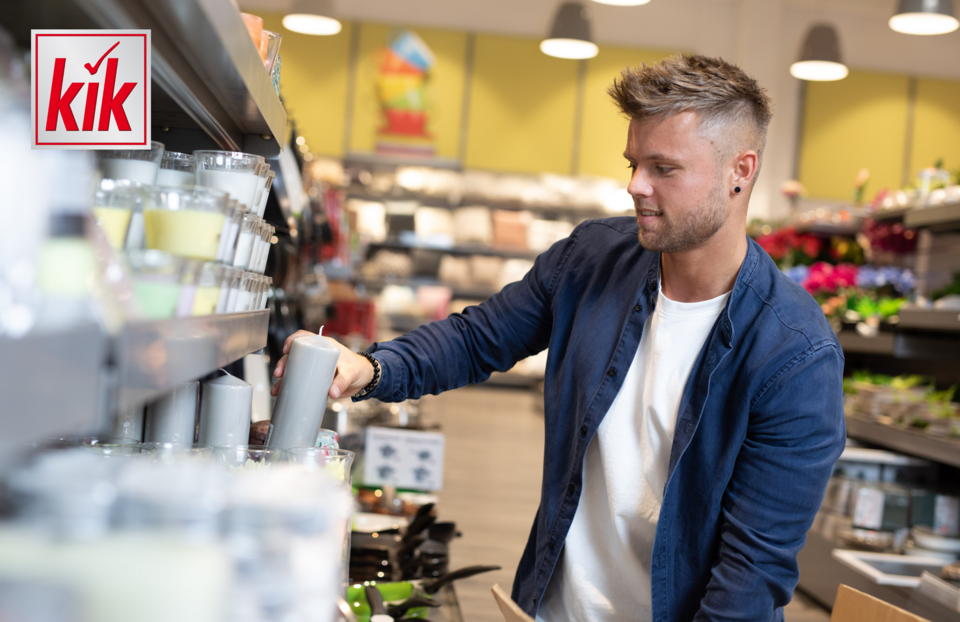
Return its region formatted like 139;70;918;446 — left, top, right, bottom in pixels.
0;324;107;473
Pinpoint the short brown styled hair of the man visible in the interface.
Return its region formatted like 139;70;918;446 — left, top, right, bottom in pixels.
607;54;773;166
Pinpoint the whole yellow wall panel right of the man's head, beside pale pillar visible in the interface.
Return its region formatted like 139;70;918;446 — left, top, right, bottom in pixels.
800;70;908;200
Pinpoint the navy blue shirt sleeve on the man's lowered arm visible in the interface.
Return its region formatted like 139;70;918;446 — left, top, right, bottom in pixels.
694;342;846;622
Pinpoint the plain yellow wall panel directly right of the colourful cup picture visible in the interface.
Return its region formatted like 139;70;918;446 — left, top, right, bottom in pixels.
464;35;577;174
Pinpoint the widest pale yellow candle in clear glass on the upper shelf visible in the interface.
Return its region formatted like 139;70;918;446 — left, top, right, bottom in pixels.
143;209;224;260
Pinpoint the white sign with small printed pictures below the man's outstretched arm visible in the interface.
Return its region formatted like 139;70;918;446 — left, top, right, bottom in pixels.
363;427;446;490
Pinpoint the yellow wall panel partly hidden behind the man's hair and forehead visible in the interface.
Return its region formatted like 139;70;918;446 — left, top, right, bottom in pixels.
577;45;673;182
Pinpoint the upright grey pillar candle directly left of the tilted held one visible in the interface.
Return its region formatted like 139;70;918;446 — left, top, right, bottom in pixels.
197;374;253;447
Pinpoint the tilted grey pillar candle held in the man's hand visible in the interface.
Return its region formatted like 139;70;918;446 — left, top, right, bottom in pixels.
266;335;340;449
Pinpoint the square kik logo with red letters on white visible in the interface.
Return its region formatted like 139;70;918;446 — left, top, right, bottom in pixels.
32;30;150;149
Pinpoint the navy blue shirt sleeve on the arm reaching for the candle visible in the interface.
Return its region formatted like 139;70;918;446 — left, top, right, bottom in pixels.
367;225;583;402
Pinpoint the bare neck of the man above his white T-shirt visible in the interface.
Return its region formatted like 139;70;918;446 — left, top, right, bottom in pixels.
660;223;747;302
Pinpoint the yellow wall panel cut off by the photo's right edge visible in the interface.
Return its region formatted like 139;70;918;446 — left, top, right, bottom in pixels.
910;78;960;181
